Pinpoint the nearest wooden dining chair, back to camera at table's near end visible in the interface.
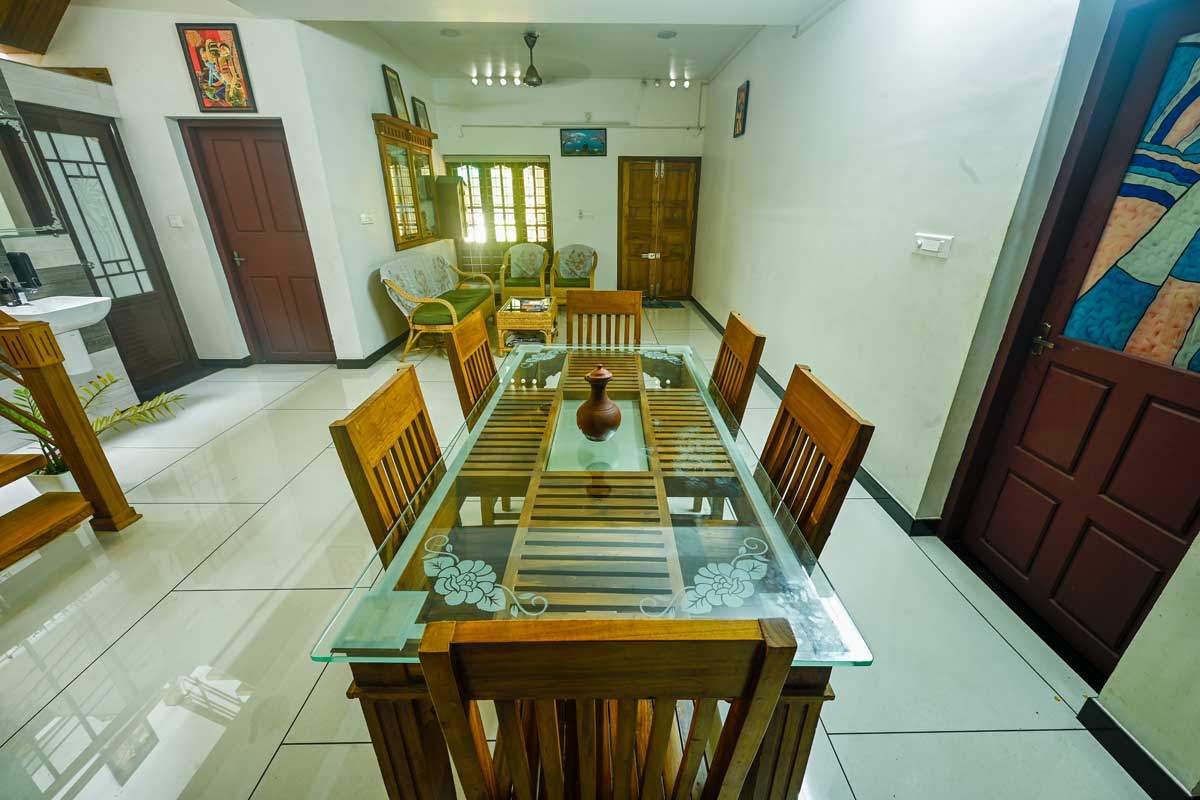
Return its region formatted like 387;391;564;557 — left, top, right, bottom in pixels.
420;619;796;800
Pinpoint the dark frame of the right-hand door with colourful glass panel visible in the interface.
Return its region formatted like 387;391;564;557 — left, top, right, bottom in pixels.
937;0;1194;543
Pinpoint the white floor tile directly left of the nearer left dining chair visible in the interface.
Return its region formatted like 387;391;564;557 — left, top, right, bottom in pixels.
180;450;376;589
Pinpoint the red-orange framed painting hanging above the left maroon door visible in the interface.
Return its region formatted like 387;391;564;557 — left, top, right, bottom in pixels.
175;23;258;113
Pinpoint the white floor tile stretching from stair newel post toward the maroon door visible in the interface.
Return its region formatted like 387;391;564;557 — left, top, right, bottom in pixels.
128;411;337;503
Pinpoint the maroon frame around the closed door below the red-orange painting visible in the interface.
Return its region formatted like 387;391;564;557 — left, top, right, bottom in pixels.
178;116;337;363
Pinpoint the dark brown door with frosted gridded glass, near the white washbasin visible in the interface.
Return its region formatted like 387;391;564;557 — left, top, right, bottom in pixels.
20;103;197;398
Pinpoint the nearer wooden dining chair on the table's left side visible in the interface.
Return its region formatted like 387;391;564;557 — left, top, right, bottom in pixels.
329;365;442;563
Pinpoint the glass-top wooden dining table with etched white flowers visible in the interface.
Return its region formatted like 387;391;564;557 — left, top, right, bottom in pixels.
312;344;871;798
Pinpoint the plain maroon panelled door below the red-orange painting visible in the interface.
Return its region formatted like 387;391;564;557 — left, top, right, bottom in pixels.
181;121;334;361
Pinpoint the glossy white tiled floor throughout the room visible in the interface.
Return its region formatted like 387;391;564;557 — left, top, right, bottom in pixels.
0;303;1145;800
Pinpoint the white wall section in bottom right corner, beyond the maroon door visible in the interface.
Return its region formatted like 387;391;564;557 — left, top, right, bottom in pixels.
1100;539;1200;795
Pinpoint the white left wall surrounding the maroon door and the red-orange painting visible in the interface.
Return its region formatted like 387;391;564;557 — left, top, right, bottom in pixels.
42;0;441;359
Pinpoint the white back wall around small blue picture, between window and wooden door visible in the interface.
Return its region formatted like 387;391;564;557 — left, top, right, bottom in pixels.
434;78;703;289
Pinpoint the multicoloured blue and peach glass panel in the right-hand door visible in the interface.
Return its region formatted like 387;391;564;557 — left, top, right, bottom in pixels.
1063;34;1200;372
